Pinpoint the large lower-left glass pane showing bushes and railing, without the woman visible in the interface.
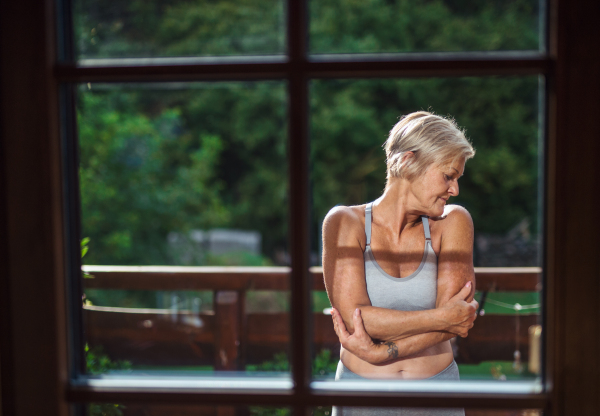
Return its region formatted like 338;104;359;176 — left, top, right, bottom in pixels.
77;82;289;374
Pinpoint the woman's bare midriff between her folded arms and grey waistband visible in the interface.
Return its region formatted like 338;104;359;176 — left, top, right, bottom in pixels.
340;341;454;380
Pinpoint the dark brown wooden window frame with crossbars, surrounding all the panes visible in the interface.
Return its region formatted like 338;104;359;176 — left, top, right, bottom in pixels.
0;0;600;416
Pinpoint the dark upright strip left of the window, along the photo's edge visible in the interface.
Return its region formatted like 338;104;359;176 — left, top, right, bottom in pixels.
0;0;66;416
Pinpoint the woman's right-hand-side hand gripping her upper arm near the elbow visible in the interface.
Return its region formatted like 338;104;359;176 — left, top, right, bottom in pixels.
440;282;479;338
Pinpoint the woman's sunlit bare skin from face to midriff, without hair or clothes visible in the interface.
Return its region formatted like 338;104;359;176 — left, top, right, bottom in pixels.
323;152;478;378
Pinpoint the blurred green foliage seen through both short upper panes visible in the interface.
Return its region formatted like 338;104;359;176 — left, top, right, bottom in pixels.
75;0;540;58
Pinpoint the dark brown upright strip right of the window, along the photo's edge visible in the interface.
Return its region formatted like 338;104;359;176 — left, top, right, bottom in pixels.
547;1;600;415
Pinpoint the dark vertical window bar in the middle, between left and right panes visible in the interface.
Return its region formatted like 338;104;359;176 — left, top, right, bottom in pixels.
287;0;312;395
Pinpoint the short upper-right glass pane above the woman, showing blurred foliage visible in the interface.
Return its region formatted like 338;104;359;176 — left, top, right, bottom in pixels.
310;0;542;53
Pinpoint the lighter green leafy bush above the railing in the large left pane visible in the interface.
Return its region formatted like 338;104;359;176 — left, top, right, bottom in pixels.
79;92;234;264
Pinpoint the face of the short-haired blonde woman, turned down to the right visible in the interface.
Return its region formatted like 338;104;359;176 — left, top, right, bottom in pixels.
411;158;465;217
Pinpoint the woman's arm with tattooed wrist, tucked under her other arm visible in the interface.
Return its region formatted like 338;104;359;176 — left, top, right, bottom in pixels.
332;206;478;364
